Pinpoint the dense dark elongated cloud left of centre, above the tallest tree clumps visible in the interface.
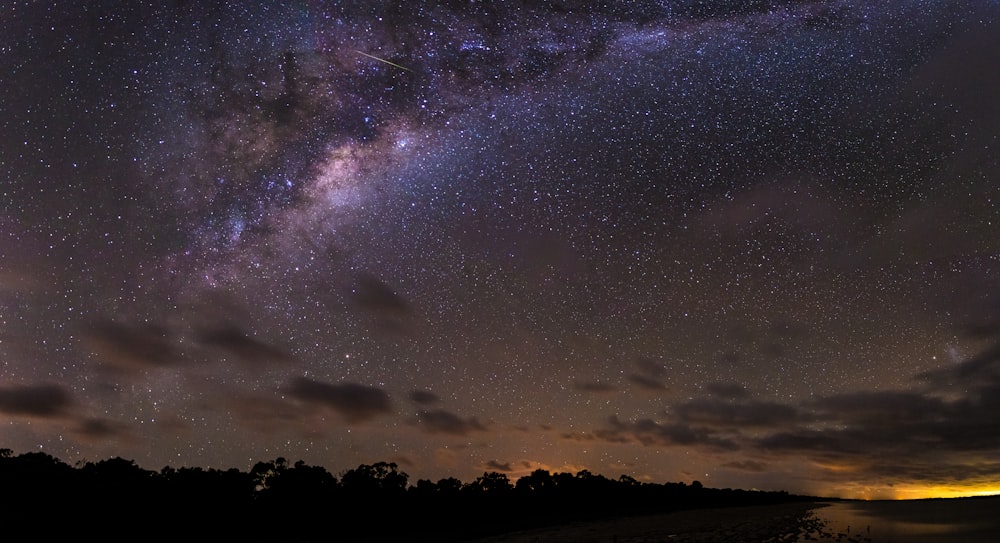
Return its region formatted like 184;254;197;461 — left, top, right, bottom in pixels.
287;377;392;423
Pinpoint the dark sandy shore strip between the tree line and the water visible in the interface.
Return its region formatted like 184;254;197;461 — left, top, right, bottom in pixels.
466;502;847;543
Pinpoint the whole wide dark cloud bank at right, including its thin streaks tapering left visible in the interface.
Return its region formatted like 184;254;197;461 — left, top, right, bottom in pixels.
588;336;1000;483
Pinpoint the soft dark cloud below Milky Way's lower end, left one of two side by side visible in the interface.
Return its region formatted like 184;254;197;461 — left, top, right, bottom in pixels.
85;321;181;371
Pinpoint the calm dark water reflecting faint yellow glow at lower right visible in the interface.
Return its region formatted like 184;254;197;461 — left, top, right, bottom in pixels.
800;498;1000;543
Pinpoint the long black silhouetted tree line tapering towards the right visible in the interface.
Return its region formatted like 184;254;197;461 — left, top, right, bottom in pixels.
0;449;813;541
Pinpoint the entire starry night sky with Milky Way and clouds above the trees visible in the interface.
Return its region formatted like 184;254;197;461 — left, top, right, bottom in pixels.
0;0;1000;497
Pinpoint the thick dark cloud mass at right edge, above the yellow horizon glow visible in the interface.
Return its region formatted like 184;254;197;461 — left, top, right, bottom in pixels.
750;340;1000;483
